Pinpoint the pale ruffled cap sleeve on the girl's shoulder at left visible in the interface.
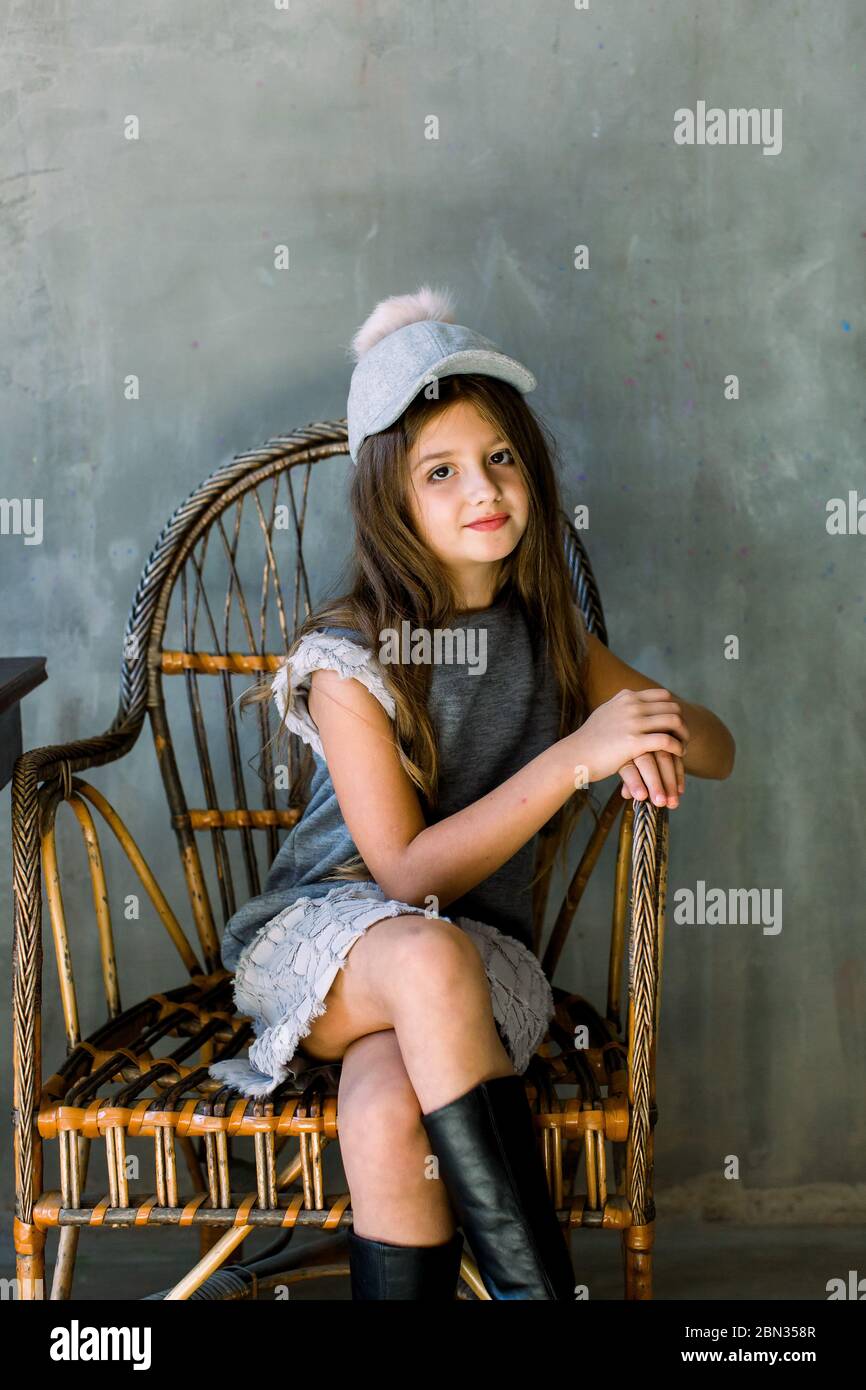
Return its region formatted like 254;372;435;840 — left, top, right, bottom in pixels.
271;632;396;759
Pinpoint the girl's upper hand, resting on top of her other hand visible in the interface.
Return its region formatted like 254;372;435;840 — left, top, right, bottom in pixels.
564;688;689;785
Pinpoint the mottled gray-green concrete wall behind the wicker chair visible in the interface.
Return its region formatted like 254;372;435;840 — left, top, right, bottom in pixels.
0;0;866;1218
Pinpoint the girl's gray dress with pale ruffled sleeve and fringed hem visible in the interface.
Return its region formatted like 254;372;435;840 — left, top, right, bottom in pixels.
210;595;559;1095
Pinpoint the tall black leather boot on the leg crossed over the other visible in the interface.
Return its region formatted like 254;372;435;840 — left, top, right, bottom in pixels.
421;1074;574;1301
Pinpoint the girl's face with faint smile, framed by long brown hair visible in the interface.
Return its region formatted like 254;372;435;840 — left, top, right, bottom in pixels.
409;400;530;607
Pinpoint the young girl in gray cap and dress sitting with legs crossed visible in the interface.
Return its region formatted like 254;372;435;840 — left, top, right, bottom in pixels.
210;286;734;1300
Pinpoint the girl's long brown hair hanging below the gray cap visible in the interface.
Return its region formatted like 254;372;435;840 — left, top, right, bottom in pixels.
240;374;600;883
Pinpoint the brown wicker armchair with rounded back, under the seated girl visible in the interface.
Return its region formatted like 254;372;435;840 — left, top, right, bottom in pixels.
13;421;669;1300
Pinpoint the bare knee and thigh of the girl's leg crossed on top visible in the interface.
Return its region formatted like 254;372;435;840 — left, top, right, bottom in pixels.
302;915;514;1113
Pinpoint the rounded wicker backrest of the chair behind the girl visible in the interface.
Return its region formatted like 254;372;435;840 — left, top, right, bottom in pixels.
123;421;606;969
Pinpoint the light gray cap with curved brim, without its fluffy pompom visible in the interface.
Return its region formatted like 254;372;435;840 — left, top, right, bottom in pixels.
346;318;538;464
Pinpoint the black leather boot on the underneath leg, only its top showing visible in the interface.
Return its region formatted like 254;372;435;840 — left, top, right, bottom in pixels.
349;1230;463;1302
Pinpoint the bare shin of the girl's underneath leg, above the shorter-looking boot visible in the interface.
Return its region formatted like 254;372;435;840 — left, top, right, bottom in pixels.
338;1029;456;1245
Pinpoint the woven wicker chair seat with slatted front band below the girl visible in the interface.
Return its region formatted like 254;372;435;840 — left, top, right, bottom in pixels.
35;970;639;1251
